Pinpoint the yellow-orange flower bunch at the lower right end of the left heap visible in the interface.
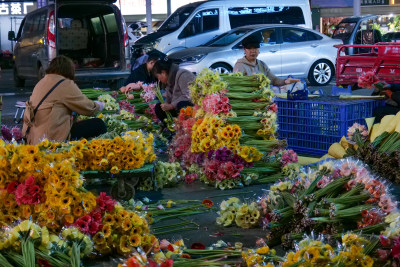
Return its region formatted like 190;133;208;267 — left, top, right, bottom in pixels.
97;205;159;255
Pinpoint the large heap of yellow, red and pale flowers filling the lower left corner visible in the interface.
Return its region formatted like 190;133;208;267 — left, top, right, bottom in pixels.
0;140;157;267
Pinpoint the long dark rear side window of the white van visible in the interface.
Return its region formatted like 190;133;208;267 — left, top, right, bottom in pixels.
228;6;305;28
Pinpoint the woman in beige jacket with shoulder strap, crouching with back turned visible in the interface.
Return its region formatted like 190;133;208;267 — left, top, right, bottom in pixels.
22;56;107;144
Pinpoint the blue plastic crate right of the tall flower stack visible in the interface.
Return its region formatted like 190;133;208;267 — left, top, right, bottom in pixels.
275;96;384;156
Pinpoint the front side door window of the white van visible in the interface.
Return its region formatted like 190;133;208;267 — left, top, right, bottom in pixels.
179;8;219;38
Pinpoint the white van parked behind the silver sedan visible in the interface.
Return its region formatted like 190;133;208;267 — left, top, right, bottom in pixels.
132;0;312;55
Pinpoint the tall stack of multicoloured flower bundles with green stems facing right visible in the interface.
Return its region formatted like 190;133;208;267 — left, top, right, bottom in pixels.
169;70;294;189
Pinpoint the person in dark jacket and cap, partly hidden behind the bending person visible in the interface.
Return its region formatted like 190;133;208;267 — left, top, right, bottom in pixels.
125;53;159;86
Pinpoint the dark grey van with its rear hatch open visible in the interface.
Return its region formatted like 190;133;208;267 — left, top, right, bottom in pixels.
9;0;130;88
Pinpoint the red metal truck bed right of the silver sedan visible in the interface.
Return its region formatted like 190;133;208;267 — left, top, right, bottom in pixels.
336;43;400;87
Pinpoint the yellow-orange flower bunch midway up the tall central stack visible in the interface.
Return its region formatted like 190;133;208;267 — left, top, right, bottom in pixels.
191;117;242;153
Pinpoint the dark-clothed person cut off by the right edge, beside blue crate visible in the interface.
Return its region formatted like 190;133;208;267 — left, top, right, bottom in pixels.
372;83;400;123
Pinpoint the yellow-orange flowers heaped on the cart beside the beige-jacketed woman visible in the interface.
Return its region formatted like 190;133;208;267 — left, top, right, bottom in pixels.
69;131;156;174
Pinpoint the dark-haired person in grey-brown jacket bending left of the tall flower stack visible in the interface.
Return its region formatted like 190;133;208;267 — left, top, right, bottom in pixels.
153;59;196;121
